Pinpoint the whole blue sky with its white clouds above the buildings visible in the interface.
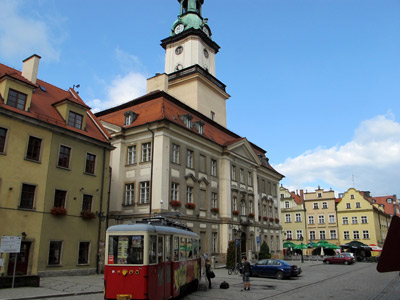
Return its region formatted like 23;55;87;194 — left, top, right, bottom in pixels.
0;0;400;196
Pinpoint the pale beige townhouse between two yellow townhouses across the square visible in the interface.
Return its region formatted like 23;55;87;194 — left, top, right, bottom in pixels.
304;188;339;245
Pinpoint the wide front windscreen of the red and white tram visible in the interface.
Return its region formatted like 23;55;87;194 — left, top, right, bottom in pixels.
108;235;143;265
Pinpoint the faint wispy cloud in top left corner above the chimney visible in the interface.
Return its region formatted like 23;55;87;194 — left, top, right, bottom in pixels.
0;0;63;61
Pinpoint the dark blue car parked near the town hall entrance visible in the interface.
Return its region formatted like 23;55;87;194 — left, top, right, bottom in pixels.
250;259;301;279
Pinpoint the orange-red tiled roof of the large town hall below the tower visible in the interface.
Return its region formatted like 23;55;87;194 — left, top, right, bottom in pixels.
96;91;283;177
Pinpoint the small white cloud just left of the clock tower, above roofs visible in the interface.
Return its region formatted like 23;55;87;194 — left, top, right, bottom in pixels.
87;72;146;113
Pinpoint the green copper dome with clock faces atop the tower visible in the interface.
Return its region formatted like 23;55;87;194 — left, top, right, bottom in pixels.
171;0;211;37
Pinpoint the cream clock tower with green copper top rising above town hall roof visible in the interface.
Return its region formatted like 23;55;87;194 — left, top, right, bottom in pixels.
147;0;230;127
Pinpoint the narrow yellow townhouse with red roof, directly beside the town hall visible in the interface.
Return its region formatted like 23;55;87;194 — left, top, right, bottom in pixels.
280;186;308;244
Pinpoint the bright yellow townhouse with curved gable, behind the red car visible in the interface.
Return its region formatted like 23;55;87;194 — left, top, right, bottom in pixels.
337;188;391;247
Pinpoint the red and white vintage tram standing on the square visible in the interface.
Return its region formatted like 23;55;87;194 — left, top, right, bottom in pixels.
104;218;201;300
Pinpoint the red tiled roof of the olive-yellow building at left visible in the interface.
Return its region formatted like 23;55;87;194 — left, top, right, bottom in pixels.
0;63;109;144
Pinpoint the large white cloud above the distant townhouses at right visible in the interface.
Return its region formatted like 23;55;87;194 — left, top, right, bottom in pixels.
274;114;400;196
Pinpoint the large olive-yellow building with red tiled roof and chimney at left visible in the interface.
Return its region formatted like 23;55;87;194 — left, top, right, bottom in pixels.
0;55;112;275
